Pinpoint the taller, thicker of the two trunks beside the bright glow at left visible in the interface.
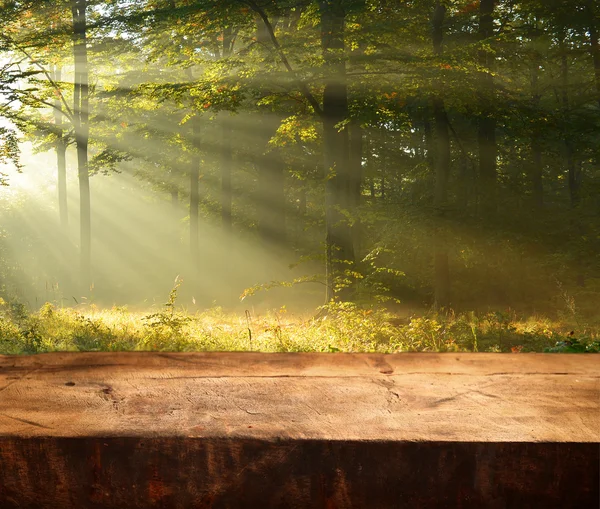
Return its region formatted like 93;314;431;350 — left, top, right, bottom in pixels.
71;0;92;293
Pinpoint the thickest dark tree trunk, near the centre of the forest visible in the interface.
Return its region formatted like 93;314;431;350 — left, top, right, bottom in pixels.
319;0;354;301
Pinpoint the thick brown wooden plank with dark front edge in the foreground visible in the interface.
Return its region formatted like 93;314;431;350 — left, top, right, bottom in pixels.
0;352;600;509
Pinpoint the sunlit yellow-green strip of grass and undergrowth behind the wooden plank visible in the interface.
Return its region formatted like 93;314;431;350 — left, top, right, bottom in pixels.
0;301;600;354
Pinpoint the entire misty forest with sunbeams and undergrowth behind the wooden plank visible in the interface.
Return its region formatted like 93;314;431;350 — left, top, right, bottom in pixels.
0;0;600;354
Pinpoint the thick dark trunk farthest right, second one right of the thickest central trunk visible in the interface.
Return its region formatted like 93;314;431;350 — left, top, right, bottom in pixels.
477;0;497;219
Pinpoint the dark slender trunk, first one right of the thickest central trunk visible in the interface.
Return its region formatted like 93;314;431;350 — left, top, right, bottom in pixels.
432;2;451;309
